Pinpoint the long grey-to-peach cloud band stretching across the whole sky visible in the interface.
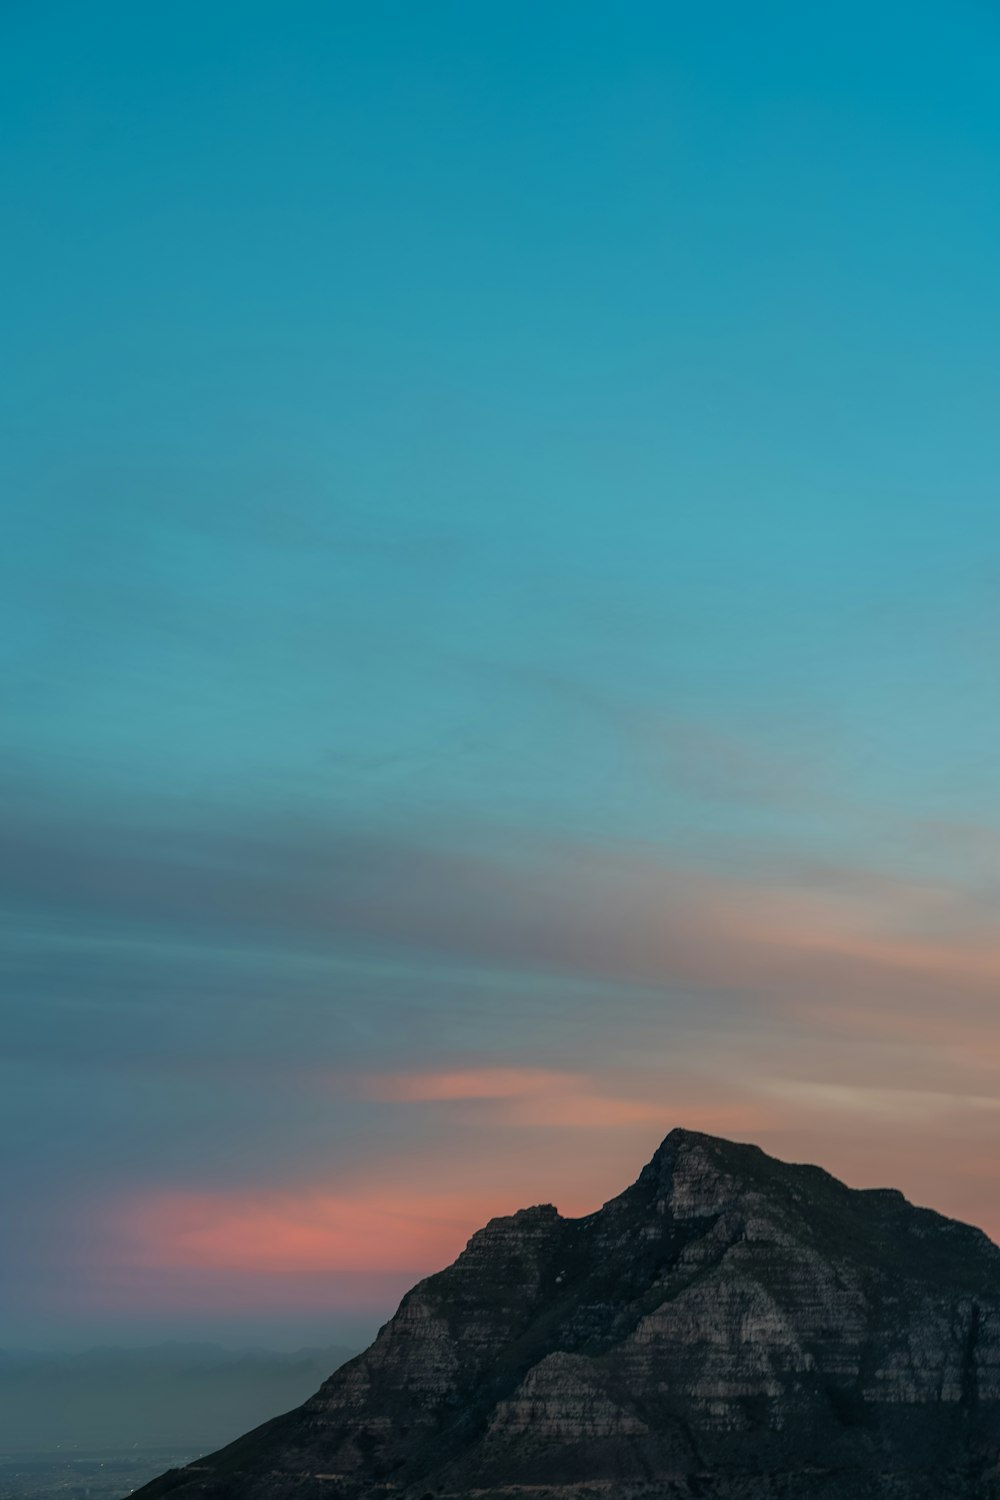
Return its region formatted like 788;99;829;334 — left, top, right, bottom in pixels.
7;768;1000;1014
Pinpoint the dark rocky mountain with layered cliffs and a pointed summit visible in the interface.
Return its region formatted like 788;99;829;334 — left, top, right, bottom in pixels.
139;1131;1000;1500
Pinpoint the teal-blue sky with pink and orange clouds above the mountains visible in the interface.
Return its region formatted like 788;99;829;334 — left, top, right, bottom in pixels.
0;0;1000;1347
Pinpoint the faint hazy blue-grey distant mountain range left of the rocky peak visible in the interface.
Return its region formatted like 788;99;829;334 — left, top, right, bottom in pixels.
0;1344;354;1452
